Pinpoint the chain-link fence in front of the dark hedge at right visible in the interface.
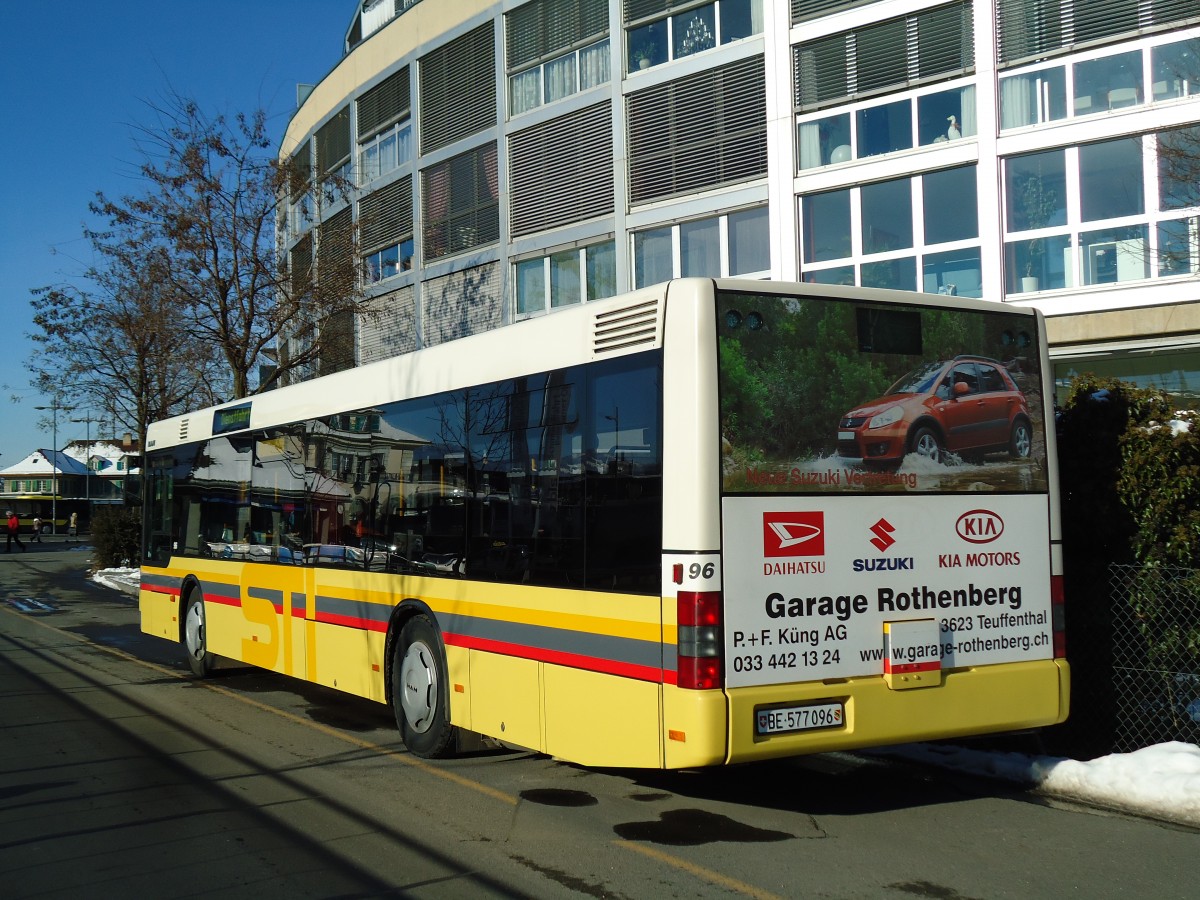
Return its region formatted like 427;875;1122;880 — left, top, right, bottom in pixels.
1109;565;1200;752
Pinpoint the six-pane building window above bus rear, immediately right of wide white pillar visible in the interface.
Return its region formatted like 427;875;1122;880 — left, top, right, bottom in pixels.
800;166;983;298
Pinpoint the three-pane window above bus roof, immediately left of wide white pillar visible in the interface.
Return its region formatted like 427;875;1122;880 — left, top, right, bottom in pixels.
634;206;770;288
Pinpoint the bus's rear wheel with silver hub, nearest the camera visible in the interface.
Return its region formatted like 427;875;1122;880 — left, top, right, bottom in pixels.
391;616;455;760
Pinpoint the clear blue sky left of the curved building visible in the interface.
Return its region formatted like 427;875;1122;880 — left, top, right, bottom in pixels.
0;0;356;469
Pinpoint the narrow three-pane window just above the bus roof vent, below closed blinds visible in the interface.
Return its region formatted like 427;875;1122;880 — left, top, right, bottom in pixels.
514;241;617;318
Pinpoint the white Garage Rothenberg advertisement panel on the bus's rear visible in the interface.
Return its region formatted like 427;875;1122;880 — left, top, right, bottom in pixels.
722;493;1054;688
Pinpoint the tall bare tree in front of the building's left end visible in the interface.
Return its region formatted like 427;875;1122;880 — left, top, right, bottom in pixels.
95;96;365;397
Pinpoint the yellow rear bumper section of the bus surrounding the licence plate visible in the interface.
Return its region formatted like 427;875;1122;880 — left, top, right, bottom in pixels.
730;659;1070;762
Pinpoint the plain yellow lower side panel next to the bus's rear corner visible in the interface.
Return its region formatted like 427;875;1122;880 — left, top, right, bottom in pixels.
542;664;662;768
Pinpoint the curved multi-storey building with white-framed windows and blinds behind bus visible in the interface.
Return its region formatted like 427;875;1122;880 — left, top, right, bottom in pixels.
280;0;1200;403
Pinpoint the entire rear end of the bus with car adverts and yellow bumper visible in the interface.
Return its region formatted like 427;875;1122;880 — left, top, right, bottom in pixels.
667;283;1068;762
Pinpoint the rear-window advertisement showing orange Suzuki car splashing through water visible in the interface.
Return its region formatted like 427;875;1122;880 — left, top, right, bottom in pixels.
718;293;1049;496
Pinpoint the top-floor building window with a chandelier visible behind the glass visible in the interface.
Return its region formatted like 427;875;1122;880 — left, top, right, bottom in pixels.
625;0;762;72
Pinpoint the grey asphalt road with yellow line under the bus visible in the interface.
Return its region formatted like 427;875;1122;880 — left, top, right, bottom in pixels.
0;544;1200;900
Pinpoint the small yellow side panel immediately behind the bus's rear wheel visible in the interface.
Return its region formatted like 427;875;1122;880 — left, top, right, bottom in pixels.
470;650;545;750
